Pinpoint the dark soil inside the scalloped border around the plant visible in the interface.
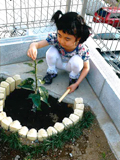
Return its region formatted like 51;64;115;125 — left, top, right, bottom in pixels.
4;89;73;130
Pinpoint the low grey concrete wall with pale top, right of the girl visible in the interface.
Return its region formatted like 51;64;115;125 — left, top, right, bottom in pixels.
87;38;120;132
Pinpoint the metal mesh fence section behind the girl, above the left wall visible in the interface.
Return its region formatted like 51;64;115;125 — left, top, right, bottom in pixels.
0;0;82;38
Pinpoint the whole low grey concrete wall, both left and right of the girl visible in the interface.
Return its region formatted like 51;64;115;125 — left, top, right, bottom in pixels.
0;36;120;132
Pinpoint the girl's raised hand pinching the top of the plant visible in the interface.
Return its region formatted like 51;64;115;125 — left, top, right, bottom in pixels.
27;44;37;60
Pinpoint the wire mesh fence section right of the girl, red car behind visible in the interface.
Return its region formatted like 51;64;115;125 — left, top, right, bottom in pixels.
88;4;120;78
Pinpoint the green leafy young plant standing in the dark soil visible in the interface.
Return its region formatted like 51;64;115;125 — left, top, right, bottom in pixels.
19;60;50;112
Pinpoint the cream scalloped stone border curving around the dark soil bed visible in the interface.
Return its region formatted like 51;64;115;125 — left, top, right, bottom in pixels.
0;75;84;142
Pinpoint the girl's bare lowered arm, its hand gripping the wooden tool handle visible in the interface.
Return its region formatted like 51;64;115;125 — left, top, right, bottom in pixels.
67;60;90;93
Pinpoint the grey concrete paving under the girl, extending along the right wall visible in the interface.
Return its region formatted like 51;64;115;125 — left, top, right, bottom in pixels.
0;60;120;160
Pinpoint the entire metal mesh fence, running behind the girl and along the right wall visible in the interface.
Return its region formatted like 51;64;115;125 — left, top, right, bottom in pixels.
0;0;120;75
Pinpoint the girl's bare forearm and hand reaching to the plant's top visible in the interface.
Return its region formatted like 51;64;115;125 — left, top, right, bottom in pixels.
27;40;49;60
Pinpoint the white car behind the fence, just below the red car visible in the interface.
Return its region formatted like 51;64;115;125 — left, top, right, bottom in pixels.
89;23;120;52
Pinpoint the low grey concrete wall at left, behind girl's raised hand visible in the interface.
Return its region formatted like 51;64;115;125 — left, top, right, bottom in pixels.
0;35;48;66
